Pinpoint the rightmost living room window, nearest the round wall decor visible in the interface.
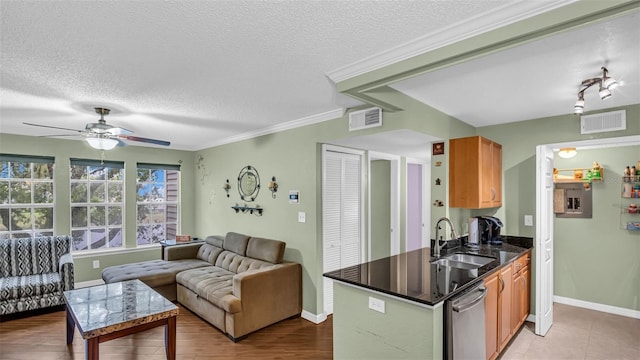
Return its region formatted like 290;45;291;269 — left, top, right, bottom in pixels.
136;163;180;245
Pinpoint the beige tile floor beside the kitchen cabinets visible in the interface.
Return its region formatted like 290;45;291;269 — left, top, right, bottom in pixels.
499;303;640;360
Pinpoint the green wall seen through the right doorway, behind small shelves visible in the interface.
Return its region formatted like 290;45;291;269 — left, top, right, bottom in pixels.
553;144;640;310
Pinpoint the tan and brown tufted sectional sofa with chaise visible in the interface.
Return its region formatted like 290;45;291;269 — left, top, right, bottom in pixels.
102;232;302;341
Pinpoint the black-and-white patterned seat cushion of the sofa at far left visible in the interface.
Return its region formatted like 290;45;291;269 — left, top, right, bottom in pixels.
0;272;64;301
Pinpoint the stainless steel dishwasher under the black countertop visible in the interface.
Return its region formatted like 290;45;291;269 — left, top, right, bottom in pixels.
445;282;487;360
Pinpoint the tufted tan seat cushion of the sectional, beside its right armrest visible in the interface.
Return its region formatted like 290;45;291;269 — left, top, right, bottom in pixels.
176;266;242;313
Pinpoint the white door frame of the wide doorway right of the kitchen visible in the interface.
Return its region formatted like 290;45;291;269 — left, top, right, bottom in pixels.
535;135;640;336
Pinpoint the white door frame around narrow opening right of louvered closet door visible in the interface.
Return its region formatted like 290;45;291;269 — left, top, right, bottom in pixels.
367;151;400;261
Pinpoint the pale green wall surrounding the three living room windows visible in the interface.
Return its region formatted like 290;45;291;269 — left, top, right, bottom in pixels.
0;134;195;282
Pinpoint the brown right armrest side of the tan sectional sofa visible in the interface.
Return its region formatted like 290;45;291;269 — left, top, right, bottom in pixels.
233;262;302;319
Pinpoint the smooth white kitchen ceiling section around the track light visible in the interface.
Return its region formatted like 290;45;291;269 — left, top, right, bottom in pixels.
391;12;640;130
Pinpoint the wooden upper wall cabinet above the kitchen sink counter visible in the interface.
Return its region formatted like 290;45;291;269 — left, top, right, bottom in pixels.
449;136;502;209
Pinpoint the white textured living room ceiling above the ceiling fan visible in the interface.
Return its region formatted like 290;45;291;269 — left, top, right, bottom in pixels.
0;0;637;150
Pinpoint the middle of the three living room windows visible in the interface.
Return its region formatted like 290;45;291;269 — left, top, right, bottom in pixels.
69;159;124;251
